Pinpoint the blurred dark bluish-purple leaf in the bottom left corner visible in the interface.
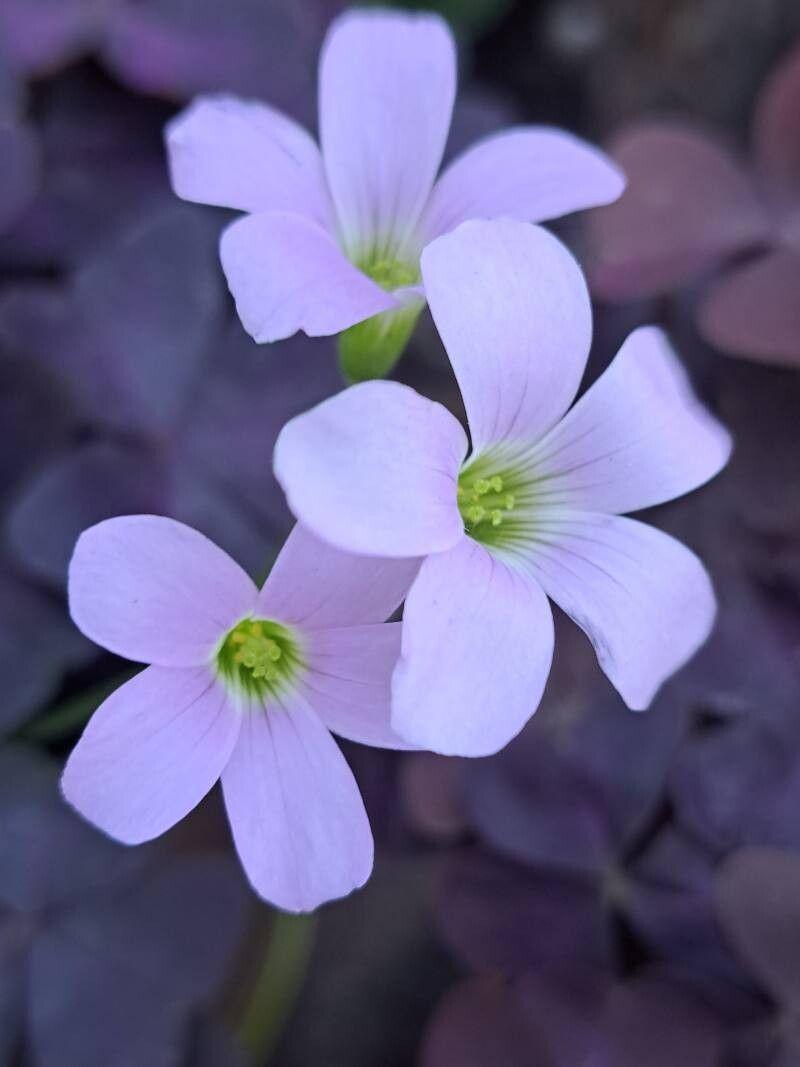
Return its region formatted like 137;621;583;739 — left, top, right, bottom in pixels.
0;747;247;1067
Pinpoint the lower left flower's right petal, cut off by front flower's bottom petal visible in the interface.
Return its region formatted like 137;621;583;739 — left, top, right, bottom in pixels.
305;622;414;749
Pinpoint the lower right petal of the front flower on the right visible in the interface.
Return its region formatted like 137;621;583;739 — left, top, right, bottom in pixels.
527;510;716;711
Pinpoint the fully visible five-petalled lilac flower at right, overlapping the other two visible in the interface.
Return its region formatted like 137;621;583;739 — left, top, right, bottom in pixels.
275;220;731;755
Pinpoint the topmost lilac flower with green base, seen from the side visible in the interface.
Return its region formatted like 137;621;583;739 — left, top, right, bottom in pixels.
166;11;624;380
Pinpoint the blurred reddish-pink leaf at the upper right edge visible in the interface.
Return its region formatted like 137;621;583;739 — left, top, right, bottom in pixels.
589;42;800;366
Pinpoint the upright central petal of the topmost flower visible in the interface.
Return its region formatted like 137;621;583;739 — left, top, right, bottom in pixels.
320;11;455;255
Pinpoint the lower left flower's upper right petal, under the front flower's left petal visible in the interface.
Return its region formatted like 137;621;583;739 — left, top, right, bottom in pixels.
255;523;419;631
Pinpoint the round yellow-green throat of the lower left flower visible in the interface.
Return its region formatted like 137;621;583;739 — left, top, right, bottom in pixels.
217;619;303;701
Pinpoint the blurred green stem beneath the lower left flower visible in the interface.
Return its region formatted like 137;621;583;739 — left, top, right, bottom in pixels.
239;911;317;1065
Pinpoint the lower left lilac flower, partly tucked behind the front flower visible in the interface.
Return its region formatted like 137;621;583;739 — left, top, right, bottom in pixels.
62;515;417;911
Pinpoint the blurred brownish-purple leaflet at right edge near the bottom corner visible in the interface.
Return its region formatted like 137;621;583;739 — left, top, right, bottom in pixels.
717;846;800;1004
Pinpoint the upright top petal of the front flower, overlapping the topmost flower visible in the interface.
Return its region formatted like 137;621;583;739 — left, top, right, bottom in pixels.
422;220;592;452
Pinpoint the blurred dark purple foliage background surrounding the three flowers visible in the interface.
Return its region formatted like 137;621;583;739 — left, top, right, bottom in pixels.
0;0;800;1067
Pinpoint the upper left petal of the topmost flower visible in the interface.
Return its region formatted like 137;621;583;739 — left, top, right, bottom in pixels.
166;95;331;226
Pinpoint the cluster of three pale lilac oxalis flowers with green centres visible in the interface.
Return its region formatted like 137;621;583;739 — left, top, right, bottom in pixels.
57;12;731;911
